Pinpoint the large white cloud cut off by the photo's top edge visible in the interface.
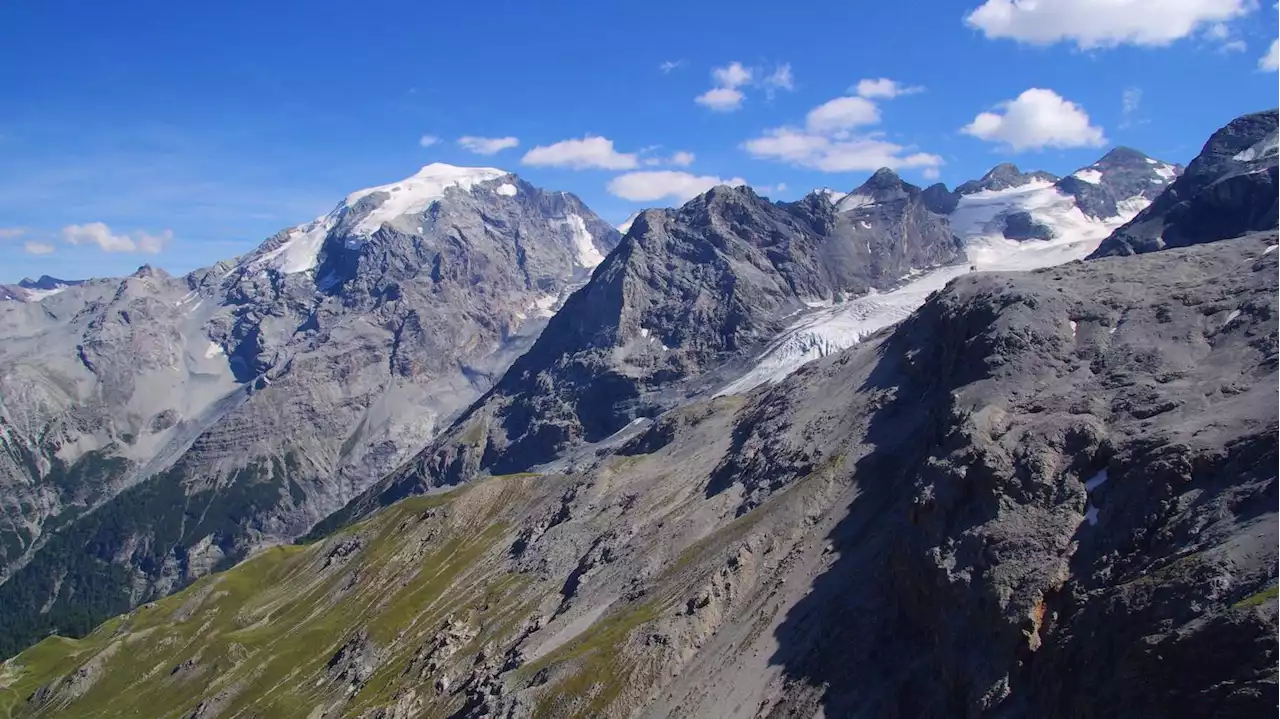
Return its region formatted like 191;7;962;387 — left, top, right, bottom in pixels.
964;0;1257;49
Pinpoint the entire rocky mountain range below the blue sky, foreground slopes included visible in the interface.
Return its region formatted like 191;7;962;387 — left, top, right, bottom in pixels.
0;106;1280;719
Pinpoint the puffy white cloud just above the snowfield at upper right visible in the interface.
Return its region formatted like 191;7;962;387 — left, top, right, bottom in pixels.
960;87;1107;152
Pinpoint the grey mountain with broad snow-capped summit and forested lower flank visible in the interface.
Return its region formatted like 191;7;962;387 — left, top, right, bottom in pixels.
0;165;618;654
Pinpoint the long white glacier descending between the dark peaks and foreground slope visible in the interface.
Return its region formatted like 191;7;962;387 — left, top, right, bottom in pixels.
719;180;1149;394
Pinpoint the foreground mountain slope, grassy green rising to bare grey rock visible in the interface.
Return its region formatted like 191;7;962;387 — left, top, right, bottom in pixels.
0;234;1280;719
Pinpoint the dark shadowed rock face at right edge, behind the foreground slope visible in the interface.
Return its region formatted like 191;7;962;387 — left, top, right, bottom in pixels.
1093;110;1280;257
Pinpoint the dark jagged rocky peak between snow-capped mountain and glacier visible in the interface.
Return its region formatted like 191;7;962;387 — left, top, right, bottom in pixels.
321;171;961;516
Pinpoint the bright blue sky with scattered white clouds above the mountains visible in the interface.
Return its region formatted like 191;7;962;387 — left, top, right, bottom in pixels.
0;0;1280;281
